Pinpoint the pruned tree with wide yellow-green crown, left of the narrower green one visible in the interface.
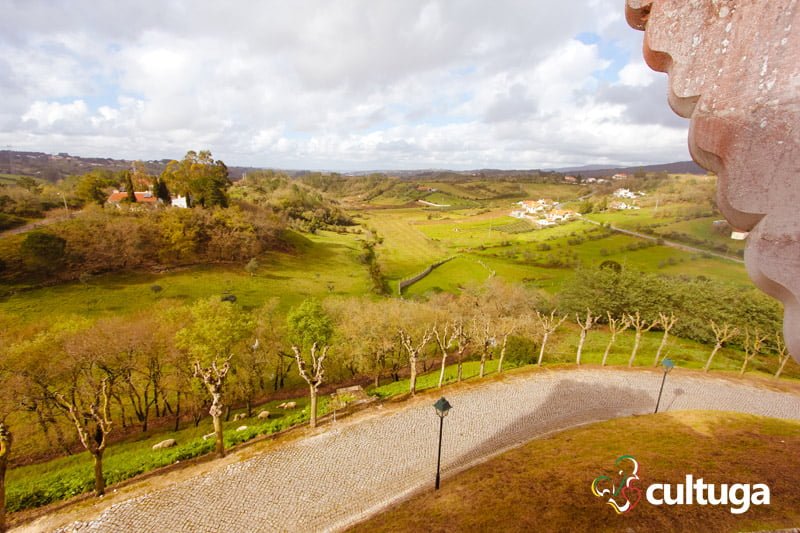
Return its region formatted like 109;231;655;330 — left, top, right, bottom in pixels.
175;298;253;457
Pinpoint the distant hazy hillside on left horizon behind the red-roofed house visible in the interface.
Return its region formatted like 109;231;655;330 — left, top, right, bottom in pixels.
0;150;253;182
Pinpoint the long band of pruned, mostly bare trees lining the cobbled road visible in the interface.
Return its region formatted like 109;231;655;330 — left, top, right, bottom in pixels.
0;282;789;528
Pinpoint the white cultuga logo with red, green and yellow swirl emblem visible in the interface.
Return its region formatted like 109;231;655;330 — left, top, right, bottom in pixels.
592;455;770;514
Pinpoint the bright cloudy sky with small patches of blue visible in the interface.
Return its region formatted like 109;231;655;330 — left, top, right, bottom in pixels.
0;0;690;171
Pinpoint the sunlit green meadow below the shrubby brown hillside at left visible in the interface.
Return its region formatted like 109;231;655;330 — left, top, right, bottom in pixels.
0;231;370;321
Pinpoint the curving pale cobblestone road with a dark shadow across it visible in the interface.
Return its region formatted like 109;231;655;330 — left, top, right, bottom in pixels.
47;369;800;533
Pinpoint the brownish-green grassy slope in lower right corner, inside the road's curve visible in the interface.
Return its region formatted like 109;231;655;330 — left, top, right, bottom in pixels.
353;411;800;532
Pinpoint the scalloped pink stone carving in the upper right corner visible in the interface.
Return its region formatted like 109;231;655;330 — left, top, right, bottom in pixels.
626;0;800;362
